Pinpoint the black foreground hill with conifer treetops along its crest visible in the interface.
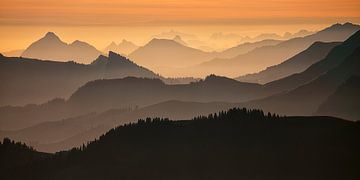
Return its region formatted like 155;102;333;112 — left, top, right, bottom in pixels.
0;109;360;180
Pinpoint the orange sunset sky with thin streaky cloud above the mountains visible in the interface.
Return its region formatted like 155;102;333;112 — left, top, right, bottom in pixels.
0;0;360;52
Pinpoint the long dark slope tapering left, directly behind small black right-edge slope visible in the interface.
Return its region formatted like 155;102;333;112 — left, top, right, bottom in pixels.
243;44;360;115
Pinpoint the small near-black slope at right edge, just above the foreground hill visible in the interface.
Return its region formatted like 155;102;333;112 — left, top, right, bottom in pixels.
316;76;360;120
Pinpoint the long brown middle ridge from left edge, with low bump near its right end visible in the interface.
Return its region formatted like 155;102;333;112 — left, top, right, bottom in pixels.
0;75;263;130
